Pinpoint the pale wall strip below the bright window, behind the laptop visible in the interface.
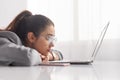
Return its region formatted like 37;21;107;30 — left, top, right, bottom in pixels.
56;39;120;61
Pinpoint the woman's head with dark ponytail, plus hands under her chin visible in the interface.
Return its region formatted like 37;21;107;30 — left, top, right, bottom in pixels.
6;10;60;62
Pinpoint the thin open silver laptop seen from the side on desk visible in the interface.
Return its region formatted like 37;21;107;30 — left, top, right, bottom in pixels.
42;22;110;65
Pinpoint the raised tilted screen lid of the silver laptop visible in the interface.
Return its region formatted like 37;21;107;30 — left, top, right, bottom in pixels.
91;22;110;61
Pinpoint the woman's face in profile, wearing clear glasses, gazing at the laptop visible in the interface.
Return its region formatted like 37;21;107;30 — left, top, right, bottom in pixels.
32;26;55;55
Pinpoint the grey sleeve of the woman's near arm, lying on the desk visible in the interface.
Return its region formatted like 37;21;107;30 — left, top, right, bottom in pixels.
0;39;42;66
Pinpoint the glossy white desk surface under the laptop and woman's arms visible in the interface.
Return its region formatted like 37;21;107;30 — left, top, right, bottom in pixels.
0;61;120;80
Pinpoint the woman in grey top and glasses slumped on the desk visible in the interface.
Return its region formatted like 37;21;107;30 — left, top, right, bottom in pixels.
0;10;63;66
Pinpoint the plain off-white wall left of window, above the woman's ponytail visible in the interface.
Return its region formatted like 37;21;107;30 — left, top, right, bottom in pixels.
0;0;27;28
